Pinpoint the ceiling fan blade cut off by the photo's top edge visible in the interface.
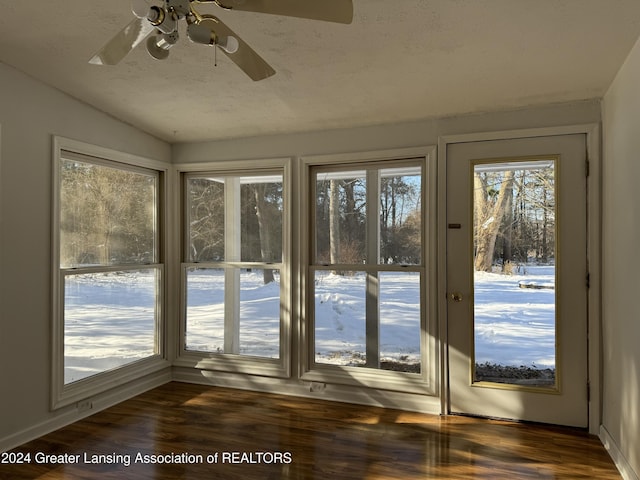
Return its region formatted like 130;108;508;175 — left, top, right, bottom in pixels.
205;0;353;24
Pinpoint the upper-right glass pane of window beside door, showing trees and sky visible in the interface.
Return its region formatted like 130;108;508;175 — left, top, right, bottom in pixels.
380;166;422;265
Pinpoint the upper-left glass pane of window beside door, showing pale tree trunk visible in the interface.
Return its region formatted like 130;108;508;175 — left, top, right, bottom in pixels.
315;171;367;265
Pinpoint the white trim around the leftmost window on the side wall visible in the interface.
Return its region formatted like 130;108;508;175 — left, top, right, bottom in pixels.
51;136;170;410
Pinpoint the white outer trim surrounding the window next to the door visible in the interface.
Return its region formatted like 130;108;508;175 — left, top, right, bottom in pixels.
297;146;441;396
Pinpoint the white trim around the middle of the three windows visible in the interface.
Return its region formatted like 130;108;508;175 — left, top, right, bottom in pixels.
173;157;294;378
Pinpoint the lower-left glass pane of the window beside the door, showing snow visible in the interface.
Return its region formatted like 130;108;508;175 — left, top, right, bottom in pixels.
314;271;367;366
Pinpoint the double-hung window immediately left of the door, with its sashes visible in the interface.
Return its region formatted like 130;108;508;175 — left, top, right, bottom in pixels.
303;150;436;392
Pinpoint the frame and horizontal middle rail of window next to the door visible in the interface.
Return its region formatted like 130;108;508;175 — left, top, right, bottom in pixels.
298;146;440;396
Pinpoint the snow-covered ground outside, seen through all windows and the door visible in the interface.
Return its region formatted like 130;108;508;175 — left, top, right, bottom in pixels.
65;266;555;382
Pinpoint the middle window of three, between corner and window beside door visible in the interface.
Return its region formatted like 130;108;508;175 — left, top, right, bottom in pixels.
178;161;291;376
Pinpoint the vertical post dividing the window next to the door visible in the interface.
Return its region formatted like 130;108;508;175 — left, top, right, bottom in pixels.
365;169;380;368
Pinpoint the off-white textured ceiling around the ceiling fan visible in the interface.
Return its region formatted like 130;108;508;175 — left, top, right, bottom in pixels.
0;0;640;142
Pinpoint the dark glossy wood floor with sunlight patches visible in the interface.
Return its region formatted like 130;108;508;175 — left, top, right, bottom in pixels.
0;383;621;480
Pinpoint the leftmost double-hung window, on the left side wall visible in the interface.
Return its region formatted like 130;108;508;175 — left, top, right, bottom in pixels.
53;139;164;405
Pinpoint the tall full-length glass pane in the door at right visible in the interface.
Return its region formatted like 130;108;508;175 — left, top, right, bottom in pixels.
473;159;557;387
